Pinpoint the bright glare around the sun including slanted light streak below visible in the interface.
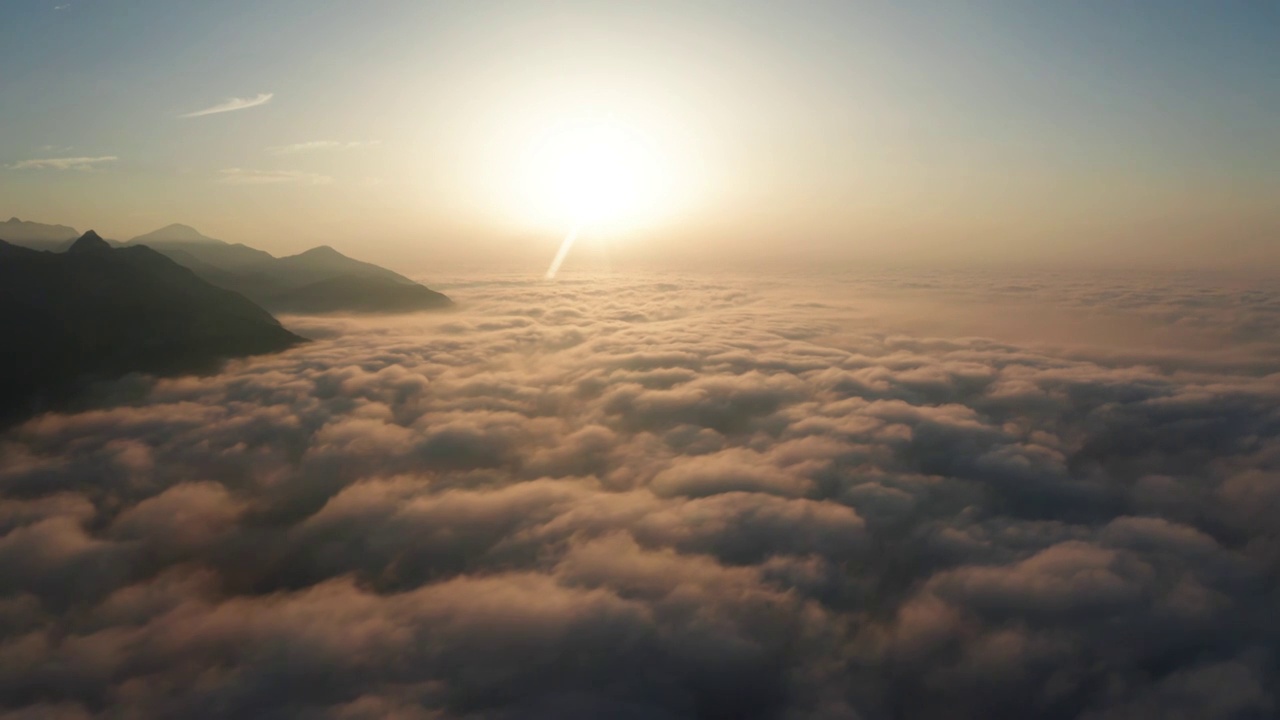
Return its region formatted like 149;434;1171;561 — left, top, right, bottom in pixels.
476;99;705;278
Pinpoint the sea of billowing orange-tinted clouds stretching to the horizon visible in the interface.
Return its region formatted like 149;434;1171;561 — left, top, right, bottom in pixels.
0;274;1280;720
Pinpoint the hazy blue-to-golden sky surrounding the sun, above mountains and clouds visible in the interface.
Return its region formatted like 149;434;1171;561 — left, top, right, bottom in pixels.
0;0;1280;266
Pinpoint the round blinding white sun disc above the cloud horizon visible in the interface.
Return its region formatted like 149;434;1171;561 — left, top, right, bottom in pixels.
525;119;669;232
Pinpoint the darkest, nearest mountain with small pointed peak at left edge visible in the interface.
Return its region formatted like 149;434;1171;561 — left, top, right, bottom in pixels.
0;231;303;423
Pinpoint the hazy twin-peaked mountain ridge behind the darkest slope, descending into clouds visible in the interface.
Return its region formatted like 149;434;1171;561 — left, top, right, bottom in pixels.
129;224;453;313
